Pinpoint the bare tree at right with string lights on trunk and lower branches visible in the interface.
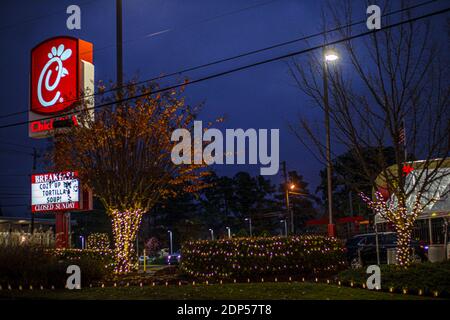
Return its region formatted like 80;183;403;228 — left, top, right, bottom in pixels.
290;1;450;266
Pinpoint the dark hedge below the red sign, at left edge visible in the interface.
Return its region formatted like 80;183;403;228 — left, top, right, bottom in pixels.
0;246;110;288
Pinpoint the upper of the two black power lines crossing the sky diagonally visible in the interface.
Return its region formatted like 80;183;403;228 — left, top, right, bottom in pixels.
0;0;439;119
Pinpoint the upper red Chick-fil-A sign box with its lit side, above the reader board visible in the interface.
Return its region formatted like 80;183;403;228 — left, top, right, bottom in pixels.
29;36;94;138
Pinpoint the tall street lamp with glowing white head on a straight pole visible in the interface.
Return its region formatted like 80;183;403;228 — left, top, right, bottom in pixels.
322;48;339;237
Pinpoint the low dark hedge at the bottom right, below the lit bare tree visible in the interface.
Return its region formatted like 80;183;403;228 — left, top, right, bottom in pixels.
337;260;450;296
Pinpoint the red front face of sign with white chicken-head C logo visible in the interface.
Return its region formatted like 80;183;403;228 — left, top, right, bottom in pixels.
31;37;79;114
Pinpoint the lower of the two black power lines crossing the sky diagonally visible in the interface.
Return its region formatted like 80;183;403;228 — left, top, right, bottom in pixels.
0;7;450;129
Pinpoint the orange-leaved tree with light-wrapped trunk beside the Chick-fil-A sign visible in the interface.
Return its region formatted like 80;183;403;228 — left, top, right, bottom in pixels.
51;84;208;274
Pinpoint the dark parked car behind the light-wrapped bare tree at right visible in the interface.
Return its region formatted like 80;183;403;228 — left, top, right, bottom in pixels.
345;232;428;268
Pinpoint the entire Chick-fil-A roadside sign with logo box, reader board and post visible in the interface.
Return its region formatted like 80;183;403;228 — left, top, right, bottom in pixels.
28;36;94;248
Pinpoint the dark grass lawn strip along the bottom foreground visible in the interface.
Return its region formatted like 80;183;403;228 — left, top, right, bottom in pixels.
0;282;436;300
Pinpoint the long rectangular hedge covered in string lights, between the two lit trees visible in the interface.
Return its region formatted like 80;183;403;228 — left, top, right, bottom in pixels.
181;235;346;280
